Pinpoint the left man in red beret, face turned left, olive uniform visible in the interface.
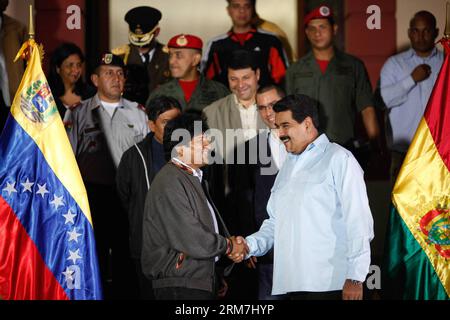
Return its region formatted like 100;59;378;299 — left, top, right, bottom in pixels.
147;34;230;111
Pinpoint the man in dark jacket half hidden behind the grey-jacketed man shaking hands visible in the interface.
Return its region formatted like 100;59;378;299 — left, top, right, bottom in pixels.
116;97;181;300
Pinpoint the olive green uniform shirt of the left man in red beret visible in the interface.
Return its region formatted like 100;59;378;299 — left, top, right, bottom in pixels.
147;76;230;111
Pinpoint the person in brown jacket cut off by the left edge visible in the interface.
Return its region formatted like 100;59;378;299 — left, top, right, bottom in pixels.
0;0;27;133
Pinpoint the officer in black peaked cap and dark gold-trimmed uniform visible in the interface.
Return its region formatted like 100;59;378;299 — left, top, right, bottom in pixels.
112;6;170;104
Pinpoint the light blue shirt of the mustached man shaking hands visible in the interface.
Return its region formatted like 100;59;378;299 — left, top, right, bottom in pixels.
246;134;373;294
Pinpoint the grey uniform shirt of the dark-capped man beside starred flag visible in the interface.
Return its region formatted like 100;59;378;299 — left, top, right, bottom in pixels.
68;95;149;180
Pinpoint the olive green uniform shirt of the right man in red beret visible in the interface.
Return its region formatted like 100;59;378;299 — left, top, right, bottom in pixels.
286;50;373;145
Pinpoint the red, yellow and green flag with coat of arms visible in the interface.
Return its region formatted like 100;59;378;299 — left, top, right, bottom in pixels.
386;39;450;300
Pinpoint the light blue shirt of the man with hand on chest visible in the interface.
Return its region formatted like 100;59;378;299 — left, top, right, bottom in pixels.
380;48;444;152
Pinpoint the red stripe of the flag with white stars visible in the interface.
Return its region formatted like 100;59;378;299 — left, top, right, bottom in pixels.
0;196;68;300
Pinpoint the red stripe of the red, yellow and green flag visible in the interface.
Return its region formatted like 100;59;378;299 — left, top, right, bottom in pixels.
425;49;450;171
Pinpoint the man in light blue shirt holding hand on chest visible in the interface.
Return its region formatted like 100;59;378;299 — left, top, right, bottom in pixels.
380;11;444;181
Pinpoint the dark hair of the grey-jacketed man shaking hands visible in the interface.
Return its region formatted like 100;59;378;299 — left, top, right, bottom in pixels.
163;113;209;161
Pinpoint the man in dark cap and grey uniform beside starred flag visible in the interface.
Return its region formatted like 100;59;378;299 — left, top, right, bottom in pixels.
68;53;149;298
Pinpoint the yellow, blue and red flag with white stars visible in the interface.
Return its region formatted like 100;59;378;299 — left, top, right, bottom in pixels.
0;39;102;300
